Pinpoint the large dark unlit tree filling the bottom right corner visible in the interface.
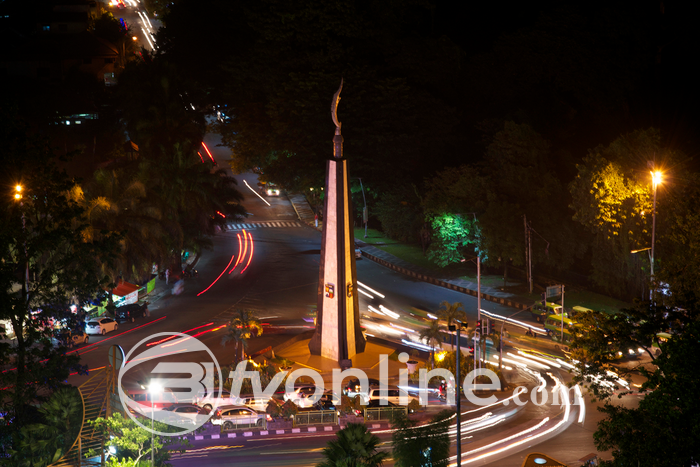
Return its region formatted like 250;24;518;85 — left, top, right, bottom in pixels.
594;321;700;466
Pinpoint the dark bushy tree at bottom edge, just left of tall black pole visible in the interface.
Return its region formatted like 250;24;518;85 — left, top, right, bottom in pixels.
391;410;454;467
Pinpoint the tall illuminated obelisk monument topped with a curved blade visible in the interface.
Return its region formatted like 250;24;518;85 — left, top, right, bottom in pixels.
309;80;365;362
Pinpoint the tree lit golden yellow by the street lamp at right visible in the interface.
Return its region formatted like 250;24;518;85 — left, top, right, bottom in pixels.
569;128;678;298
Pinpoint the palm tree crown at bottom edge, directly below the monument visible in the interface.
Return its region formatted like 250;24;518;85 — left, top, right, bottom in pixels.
316;423;389;467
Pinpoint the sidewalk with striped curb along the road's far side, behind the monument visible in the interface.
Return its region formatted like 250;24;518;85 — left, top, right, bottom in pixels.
287;193;531;310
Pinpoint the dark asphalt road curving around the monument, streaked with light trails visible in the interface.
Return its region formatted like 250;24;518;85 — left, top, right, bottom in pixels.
61;129;616;466
